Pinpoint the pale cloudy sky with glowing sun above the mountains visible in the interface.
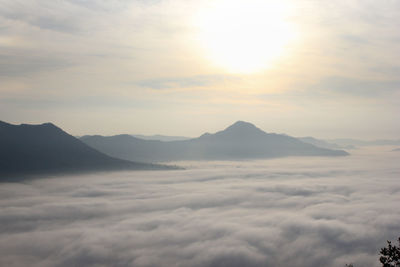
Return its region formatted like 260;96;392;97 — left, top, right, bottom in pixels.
0;0;400;139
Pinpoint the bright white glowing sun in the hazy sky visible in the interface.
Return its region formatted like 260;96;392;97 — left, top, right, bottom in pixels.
196;0;296;73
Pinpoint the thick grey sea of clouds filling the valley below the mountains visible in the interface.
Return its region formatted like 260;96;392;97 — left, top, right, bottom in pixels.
0;148;400;267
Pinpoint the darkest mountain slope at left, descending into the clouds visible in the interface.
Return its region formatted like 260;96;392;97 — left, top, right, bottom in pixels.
0;121;175;180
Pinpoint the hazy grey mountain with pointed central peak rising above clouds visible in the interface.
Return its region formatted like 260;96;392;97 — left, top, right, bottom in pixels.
81;121;348;162
